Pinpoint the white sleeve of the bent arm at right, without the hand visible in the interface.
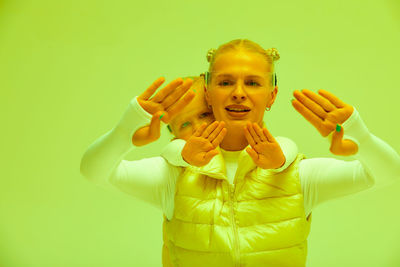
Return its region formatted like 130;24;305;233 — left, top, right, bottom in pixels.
299;105;400;216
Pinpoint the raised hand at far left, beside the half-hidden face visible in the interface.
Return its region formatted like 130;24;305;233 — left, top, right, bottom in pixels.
132;77;195;146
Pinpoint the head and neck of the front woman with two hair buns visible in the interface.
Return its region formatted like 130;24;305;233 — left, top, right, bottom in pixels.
206;40;280;150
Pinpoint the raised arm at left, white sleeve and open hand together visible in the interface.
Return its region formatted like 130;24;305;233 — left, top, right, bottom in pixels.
80;78;194;209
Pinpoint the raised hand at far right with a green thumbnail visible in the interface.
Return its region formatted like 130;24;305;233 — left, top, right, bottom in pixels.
292;89;358;156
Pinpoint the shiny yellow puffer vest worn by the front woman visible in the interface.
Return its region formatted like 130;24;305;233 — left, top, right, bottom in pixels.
162;150;311;267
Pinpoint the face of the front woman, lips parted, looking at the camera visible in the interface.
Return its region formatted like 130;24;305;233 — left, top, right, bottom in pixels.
206;51;278;130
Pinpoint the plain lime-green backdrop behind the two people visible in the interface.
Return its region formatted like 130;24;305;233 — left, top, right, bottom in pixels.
0;0;400;267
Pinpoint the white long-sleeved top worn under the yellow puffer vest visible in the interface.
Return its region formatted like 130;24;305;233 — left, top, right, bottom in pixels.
81;98;400;222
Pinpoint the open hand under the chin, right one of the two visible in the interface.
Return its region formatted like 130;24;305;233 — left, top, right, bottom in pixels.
244;122;286;169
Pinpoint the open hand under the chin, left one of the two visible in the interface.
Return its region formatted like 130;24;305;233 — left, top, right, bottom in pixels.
182;121;227;167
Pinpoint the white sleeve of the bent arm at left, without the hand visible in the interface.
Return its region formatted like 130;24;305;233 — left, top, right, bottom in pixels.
80;97;181;214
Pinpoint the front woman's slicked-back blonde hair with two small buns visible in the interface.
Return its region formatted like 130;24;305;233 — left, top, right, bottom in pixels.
205;39;280;86
